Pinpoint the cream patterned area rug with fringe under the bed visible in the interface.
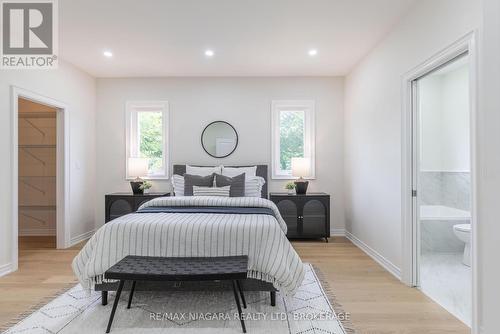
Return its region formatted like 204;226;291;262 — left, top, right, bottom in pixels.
1;264;354;334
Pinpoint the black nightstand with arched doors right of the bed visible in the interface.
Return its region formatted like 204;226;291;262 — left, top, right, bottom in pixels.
270;192;330;242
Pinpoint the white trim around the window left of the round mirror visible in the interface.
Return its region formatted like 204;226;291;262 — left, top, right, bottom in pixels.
125;101;170;180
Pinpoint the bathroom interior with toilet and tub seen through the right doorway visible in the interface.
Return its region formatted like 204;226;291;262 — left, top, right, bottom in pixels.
416;55;472;326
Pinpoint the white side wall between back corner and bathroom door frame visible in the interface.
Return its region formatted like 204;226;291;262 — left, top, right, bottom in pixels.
345;0;480;268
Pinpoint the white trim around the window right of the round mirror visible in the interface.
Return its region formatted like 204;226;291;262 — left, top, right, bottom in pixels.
271;100;316;180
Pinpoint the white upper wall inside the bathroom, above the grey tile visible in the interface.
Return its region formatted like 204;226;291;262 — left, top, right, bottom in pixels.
418;64;470;172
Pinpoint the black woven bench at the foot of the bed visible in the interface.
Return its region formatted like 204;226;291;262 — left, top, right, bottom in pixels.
104;255;248;333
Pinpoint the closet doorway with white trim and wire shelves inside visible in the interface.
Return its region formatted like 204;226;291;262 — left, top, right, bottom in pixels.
11;87;70;271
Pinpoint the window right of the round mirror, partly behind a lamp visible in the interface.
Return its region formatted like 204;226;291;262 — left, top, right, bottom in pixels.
272;101;315;179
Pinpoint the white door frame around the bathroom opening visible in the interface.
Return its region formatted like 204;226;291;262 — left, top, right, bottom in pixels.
401;31;479;334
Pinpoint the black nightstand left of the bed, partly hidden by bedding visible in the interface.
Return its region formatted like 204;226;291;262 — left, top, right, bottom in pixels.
104;193;170;223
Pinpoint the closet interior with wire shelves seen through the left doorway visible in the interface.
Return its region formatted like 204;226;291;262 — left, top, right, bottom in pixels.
18;98;57;236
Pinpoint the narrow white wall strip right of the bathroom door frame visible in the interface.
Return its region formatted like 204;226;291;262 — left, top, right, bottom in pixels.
477;0;500;334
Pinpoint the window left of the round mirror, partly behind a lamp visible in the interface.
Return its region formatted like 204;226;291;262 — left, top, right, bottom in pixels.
126;101;169;179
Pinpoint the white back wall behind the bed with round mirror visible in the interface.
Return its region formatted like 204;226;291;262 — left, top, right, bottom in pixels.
96;77;344;229
